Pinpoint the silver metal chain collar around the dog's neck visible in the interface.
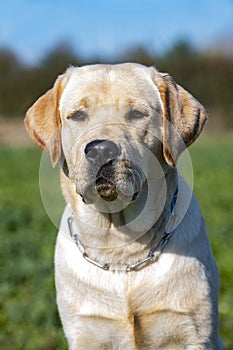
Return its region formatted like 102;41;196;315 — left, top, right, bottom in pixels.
67;188;178;272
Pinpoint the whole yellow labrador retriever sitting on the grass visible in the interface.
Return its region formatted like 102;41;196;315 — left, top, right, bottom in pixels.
25;63;223;350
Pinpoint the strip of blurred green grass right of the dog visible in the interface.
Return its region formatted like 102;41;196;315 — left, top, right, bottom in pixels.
190;135;233;349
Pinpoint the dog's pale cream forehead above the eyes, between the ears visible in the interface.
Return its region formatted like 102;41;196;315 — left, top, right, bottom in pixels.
60;64;160;117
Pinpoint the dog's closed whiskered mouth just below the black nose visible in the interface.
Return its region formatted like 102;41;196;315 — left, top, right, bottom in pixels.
95;160;145;202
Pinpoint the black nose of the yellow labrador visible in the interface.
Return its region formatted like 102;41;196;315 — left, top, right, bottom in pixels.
84;140;121;165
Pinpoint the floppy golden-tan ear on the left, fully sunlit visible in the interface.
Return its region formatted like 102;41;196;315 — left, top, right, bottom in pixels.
24;75;65;166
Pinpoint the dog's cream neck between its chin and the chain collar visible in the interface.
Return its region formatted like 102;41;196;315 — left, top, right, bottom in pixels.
61;169;177;263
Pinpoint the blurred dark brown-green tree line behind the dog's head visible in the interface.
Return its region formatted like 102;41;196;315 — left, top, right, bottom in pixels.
0;41;233;129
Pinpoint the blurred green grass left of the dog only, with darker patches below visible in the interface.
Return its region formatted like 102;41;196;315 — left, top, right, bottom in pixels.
0;148;67;350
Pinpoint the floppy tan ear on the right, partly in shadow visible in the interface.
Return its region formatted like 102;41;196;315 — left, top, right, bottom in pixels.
158;74;207;166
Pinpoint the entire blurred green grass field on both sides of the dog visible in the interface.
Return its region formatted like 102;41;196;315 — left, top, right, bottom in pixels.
0;137;233;350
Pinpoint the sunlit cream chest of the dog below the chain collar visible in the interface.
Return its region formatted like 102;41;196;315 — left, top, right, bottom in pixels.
55;230;212;349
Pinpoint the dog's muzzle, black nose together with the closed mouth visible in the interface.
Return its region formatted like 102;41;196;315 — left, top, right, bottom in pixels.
84;140;144;202
